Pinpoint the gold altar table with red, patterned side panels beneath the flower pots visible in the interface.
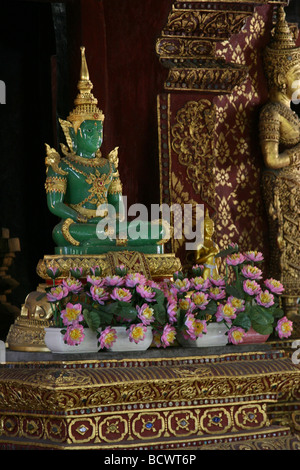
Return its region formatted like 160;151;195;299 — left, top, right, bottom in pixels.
0;345;300;450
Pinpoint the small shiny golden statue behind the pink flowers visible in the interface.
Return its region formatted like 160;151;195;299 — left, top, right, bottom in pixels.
195;209;219;279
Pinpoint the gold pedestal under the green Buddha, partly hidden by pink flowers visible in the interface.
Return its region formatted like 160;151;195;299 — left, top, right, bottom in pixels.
6;251;181;352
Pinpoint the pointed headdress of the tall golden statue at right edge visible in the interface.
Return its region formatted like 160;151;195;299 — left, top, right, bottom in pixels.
264;5;300;84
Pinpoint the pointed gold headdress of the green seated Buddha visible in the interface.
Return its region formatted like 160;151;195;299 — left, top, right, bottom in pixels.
67;47;104;133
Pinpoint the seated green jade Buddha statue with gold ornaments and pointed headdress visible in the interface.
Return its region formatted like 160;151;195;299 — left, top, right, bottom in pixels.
45;47;169;254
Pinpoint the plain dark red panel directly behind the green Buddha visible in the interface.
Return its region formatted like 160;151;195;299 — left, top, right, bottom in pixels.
69;0;172;207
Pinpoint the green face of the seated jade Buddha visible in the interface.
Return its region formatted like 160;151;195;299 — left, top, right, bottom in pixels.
76;121;103;157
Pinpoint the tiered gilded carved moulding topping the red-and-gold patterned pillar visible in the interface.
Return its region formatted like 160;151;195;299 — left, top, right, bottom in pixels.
156;2;253;93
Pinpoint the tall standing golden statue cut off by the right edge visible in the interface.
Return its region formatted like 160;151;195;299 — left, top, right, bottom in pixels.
260;6;300;315
